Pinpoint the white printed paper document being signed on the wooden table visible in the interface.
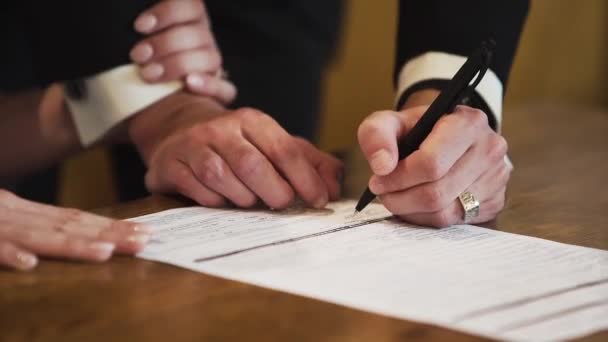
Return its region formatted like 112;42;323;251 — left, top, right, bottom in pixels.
133;201;608;341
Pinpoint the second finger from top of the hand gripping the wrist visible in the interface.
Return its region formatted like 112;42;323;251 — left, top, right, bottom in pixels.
130;22;216;64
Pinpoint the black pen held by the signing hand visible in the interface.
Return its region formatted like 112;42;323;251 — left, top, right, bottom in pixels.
355;40;496;214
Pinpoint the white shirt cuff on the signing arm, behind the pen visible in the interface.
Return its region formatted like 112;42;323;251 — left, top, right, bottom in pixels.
397;52;503;128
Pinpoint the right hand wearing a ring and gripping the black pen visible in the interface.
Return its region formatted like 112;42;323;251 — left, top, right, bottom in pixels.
358;91;512;227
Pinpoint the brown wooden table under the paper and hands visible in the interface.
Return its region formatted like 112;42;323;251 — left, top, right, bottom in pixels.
0;106;608;341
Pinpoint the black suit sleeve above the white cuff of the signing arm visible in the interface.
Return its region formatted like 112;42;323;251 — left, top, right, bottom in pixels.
395;0;529;89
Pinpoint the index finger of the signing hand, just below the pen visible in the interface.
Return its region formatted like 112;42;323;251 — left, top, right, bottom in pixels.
370;106;491;194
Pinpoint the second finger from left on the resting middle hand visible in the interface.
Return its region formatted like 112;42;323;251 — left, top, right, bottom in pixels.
189;148;257;208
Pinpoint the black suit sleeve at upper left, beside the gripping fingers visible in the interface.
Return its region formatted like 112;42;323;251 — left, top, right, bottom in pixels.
20;0;156;83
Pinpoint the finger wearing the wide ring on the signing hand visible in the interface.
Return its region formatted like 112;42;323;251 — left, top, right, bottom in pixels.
399;163;511;227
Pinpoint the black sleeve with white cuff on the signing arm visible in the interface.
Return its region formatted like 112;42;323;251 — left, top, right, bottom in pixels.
395;0;529;129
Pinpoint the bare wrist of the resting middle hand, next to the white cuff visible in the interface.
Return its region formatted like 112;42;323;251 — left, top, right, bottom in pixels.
127;91;226;163
